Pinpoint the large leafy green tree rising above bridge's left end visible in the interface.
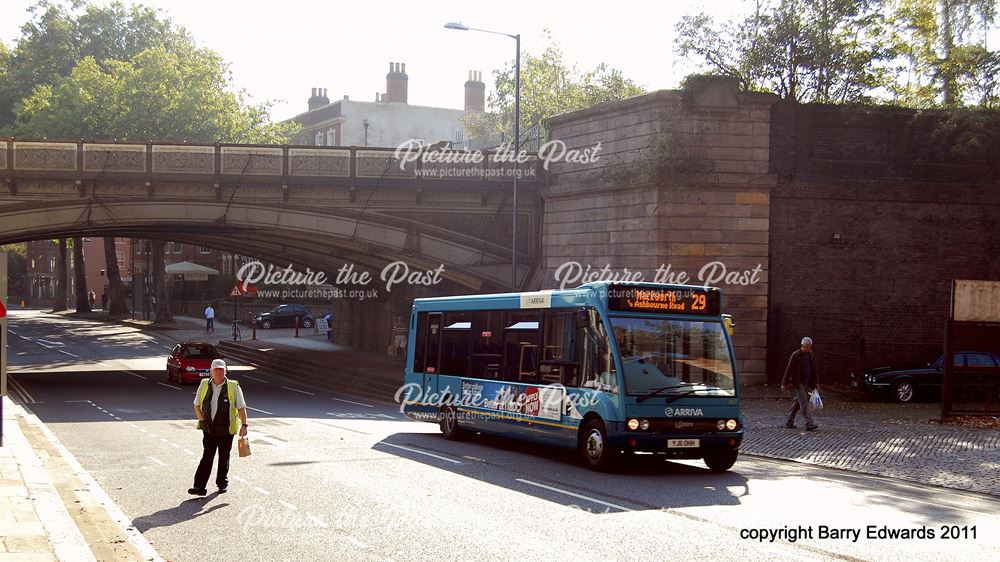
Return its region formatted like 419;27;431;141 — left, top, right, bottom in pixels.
0;0;298;322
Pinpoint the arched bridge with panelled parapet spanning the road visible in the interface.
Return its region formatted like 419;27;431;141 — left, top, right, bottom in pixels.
0;139;541;291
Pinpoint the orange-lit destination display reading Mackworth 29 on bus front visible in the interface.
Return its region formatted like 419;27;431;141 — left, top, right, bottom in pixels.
608;285;722;316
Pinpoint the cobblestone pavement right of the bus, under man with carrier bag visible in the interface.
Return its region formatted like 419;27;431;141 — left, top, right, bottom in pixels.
741;399;1000;496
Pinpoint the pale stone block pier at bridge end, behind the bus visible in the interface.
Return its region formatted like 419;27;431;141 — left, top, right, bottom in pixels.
534;79;777;382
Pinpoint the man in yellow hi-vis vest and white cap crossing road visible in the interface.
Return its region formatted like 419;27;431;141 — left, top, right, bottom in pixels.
188;359;247;496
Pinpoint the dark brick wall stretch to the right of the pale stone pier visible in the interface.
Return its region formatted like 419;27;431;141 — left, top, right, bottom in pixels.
768;104;1000;382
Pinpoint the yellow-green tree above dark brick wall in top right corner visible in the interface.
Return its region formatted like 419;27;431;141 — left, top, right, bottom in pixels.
894;0;1000;109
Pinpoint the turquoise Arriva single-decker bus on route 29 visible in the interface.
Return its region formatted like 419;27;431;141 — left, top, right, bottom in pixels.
398;282;743;472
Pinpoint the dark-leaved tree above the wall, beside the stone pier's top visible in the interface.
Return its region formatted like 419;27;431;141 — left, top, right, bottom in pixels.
675;0;895;103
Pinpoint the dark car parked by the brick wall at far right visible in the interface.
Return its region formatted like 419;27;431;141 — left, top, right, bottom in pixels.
851;351;1000;402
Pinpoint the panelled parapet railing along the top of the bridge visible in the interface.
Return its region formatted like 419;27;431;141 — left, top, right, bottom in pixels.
0;138;539;185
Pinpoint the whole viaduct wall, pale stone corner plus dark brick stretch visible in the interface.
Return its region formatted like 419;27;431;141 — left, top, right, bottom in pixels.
548;79;1000;383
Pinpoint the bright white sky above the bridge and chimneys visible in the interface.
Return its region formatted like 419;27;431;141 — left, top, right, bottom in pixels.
0;0;746;120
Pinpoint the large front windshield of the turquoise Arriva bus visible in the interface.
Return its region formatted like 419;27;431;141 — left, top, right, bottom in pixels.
611;316;736;396
